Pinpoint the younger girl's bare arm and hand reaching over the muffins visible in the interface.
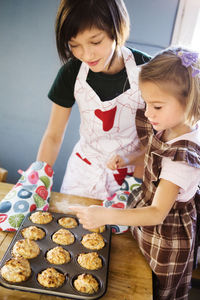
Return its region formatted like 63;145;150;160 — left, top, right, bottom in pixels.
70;179;179;229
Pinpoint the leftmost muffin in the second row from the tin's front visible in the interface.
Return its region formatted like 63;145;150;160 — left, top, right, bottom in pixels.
12;239;40;259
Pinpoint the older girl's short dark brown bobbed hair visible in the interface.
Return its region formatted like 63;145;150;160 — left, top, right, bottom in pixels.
55;0;130;62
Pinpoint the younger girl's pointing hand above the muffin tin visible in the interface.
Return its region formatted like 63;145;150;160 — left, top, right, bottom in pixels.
69;205;108;230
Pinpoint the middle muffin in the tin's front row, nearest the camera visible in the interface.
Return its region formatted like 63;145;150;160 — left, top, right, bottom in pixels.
37;268;65;288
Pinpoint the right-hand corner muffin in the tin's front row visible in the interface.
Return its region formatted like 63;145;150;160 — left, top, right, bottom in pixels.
74;274;99;294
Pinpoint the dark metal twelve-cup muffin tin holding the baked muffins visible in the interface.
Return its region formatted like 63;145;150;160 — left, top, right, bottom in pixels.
0;213;111;300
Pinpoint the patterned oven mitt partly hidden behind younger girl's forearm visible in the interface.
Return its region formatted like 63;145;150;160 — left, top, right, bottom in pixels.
102;176;142;234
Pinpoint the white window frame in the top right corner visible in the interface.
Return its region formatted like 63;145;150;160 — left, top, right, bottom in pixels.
171;0;200;46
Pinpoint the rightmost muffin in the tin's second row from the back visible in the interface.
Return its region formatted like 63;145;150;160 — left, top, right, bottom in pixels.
81;232;105;250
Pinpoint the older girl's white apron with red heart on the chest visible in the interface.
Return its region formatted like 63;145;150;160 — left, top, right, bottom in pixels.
61;47;144;200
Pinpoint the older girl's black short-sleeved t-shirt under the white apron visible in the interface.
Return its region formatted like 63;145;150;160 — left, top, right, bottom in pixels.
48;48;151;108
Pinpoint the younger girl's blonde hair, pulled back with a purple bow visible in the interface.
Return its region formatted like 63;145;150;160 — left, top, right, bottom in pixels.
139;47;200;125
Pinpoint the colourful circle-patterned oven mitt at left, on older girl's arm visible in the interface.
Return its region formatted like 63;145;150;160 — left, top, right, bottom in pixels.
0;161;53;231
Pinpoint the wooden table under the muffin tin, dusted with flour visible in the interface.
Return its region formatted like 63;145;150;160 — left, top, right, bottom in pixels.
0;183;153;300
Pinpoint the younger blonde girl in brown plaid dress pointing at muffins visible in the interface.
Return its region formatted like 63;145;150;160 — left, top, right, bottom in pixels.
71;48;200;300
